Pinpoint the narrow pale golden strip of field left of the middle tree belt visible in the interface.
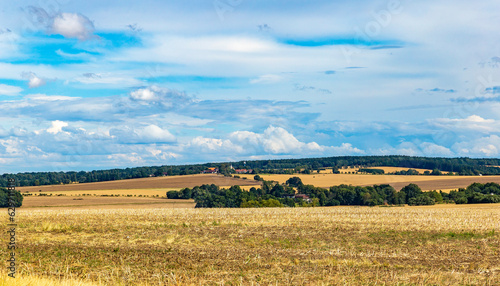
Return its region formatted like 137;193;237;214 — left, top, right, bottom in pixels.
20;196;195;209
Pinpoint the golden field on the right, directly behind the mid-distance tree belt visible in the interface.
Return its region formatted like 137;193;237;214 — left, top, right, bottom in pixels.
242;174;500;191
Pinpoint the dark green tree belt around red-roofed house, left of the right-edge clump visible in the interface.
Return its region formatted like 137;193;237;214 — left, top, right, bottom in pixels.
167;177;443;208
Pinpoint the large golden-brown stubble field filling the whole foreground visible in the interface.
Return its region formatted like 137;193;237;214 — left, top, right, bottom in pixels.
0;205;500;285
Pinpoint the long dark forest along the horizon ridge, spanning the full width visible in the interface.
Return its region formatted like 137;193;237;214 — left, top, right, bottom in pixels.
0;156;500;187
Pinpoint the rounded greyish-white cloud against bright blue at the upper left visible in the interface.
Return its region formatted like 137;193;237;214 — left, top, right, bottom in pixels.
51;13;95;41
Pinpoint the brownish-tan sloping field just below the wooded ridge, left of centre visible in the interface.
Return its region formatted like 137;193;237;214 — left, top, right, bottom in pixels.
17;174;260;192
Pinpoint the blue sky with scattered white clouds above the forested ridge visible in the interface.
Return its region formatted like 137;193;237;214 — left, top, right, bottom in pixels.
0;0;500;173
